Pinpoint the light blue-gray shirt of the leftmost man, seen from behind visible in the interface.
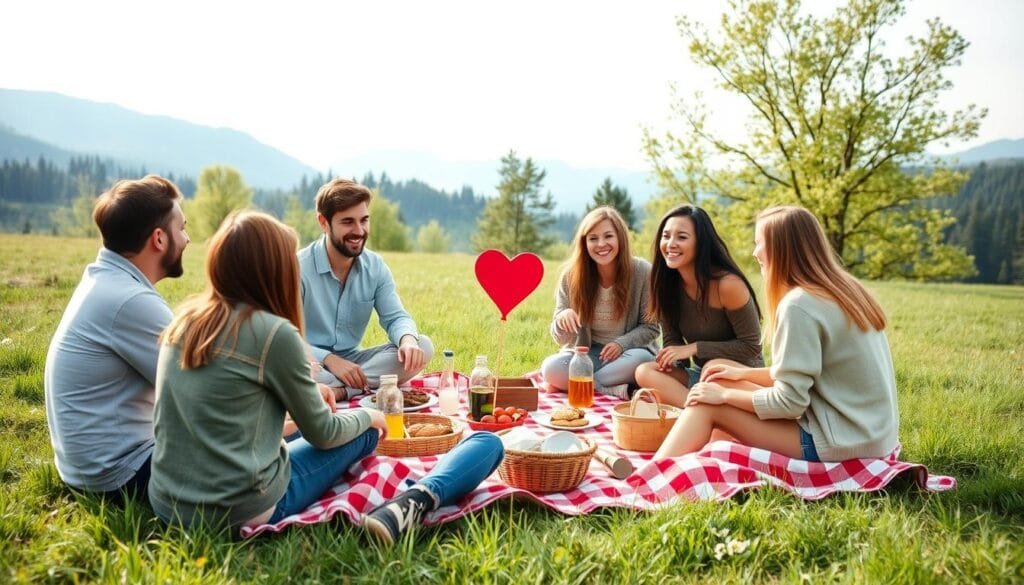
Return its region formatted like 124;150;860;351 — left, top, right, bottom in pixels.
43;248;171;492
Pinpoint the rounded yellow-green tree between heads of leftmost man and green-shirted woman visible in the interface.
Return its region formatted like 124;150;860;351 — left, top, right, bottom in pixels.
184;165;253;241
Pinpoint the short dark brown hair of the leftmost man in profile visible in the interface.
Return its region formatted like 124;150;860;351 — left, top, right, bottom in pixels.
92;175;181;254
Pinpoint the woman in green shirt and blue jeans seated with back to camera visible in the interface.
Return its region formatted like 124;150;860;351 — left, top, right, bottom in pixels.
150;212;503;542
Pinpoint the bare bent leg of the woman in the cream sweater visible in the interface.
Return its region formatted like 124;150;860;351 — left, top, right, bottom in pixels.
654;404;804;459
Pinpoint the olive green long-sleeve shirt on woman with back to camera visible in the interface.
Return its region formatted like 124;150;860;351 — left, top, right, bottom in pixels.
150;309;370;526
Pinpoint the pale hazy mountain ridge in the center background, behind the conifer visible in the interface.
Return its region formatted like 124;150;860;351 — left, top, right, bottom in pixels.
332;151;656;214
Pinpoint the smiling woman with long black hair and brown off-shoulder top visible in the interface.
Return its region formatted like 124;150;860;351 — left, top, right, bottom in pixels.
636;205;764;407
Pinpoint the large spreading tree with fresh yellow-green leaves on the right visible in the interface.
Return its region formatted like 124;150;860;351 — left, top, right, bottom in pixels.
644;0;986;279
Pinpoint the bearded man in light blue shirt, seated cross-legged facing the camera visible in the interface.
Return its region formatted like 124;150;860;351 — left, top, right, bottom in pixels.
299;178;434;399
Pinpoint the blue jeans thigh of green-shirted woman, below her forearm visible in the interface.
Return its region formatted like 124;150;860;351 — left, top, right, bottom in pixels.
267;428;380;524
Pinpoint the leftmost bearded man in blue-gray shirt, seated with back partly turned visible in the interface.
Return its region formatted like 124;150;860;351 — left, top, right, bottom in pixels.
43;175;188;501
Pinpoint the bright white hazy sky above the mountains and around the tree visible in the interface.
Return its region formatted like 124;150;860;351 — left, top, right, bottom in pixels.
0;0;1024;169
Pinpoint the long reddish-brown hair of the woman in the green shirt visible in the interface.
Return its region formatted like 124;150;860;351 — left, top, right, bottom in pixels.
163;211;303;369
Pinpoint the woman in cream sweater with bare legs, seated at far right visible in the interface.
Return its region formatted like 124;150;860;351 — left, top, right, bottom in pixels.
655;207;899;461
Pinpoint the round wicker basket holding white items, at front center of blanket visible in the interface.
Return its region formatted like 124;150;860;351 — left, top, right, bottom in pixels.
498;430;597;494
